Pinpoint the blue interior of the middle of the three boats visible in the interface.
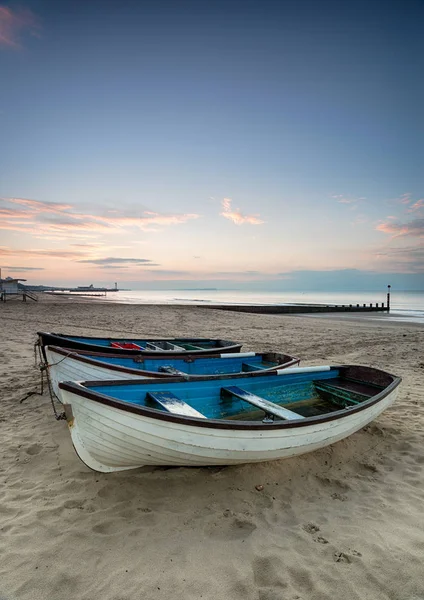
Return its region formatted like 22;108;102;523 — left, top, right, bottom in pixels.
87;355;278;375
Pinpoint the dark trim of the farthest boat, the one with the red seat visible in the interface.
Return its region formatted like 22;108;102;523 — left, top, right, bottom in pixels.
37;331;242;358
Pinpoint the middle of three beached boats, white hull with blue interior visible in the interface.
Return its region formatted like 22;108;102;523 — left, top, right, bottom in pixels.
45;346;300;400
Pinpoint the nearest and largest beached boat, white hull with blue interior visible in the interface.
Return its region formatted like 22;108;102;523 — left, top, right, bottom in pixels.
59;366;401;472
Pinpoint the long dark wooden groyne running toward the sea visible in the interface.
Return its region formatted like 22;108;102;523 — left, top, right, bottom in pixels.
196;302;390;315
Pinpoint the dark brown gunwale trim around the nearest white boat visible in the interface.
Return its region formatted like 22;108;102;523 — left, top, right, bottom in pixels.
59;365;402;430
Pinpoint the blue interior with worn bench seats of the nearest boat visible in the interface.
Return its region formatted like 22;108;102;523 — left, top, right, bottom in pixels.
85;368;384;422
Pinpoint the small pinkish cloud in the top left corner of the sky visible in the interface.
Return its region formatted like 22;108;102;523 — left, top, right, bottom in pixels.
0;5;41;49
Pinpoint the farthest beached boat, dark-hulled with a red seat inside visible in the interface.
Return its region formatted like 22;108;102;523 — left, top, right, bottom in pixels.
37;331;241;356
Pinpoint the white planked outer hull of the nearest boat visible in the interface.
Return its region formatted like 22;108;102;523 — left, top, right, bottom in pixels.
62;376;398;473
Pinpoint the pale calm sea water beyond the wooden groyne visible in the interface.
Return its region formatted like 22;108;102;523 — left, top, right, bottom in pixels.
97;290;424;324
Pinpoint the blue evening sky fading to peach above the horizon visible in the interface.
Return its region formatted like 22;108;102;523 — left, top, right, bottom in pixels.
0;0;424;290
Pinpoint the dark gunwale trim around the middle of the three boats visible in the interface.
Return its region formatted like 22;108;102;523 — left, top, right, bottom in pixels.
46;346;300;379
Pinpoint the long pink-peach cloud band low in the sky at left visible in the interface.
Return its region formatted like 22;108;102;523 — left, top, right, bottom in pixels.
0;198;200;238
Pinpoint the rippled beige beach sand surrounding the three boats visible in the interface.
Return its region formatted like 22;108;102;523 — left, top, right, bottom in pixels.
0;297;424;600
